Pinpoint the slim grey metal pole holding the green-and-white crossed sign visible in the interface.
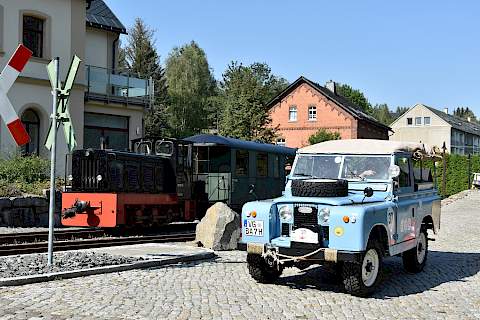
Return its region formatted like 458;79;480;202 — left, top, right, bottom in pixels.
47;57;60;266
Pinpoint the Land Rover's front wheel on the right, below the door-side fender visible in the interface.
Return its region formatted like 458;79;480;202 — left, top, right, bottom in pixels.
342;240;383;297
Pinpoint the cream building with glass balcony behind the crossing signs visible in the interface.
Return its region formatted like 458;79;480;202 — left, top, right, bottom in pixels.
0;0;150;174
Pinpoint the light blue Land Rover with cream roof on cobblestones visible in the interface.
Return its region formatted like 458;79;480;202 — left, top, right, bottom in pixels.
242;140;440;296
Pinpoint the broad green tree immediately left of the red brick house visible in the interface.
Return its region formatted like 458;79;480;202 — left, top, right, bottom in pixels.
220;62;288;142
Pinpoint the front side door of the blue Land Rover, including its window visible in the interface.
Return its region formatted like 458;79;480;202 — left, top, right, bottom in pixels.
394;154;418;244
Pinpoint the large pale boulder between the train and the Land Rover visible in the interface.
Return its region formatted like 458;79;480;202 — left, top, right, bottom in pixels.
195;202;241;250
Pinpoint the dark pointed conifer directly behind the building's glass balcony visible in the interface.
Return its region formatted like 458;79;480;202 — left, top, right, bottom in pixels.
117;18;168;136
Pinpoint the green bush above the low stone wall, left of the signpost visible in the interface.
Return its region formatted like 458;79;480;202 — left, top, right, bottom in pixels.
0;155;50;197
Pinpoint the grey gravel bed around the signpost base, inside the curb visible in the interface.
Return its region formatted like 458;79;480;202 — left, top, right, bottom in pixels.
0;251;144;278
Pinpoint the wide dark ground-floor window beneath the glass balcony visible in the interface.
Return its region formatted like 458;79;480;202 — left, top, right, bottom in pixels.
84;112;129;150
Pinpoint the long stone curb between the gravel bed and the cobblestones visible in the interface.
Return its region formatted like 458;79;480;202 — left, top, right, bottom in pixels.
0;251;215;287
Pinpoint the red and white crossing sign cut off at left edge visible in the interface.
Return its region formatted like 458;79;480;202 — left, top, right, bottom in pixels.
0;44;32;146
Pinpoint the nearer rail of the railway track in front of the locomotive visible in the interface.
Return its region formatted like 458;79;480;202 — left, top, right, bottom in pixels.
0;232;195;256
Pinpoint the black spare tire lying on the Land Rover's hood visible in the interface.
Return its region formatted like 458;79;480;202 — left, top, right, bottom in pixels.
292;179;348;197
